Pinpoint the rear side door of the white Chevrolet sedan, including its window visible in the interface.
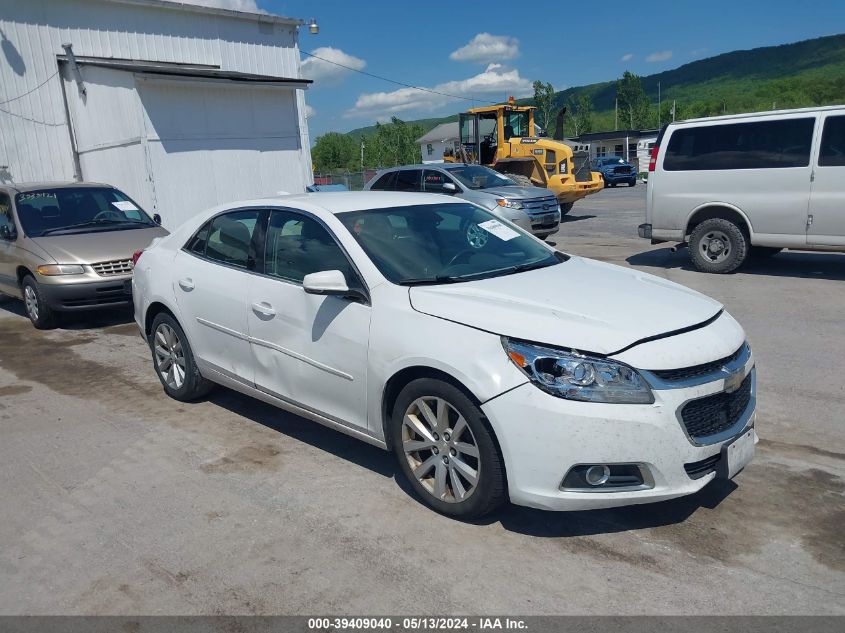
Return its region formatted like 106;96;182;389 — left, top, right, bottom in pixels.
173;209;266;386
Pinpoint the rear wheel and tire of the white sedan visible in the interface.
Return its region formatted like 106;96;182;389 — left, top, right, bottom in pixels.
149;312;214;402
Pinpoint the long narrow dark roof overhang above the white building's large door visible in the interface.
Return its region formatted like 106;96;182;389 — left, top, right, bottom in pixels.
57;55;314;90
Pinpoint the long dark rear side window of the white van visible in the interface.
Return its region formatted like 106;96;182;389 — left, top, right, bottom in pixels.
663;118;816;171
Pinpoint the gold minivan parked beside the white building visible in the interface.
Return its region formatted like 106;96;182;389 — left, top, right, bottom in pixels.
0;182;167;329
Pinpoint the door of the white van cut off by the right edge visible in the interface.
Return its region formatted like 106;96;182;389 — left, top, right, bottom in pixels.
807;114;845;246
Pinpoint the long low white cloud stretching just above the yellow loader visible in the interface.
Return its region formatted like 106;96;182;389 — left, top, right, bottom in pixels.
344;64;531;118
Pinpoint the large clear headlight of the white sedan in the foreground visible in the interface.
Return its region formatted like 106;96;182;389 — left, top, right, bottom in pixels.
502;337;654;404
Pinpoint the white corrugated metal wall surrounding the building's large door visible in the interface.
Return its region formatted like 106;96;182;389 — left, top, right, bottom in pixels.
0;0;311;182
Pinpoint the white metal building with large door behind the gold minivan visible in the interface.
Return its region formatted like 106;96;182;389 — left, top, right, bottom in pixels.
0;0;312;228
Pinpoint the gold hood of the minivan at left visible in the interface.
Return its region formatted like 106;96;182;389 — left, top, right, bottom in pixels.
32;226;167;264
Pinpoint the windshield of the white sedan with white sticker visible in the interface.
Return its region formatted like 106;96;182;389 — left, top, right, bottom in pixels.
337;203;567;285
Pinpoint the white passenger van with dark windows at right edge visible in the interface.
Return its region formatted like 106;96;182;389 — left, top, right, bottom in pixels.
639;106;845;273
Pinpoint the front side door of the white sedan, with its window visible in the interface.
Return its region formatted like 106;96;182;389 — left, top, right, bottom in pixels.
249;209;372;430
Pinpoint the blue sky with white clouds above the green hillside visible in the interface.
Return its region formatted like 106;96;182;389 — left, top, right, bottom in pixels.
214;0;845;138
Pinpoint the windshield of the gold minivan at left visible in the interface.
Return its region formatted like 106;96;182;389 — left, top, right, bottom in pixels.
15;187;155;237
